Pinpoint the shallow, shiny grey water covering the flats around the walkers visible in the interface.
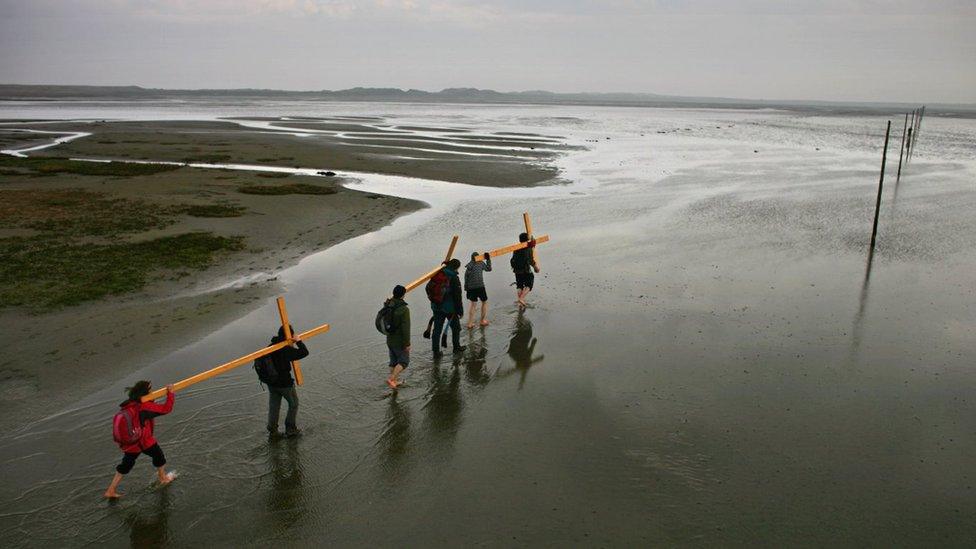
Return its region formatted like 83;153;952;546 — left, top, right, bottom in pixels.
0;103;976;546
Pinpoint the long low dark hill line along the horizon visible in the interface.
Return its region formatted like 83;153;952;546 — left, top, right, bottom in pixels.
0;84;976;116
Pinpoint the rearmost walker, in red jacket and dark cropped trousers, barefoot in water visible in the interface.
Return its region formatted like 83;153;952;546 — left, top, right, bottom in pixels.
105;381;176;499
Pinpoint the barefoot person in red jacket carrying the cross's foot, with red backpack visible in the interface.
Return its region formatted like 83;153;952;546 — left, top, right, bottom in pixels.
104;381;176;499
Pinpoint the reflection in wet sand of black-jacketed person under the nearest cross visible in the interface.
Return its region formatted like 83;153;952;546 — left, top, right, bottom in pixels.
268;438;306;530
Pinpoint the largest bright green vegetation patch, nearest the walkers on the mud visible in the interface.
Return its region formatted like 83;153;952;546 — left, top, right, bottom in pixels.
0;232;244;310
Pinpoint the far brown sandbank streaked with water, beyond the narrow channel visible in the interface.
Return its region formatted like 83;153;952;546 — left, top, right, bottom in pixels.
26;117;557;187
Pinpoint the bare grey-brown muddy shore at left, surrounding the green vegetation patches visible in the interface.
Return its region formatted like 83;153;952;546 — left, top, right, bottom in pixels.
0;117;554;428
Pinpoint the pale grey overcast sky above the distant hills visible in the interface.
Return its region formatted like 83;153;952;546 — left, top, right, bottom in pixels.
0;0;976;103
